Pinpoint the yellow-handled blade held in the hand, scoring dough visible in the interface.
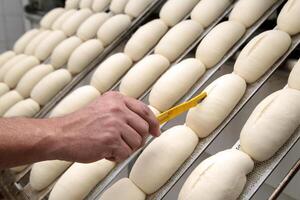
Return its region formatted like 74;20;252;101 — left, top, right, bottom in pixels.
156;92;207;124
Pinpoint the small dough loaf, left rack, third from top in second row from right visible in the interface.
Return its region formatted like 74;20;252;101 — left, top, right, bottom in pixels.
50;36;82;69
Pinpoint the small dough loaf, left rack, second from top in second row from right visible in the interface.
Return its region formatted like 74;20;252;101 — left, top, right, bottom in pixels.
77;13;110;41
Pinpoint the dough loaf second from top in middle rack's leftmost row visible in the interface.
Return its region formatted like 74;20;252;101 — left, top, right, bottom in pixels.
124;19;168;61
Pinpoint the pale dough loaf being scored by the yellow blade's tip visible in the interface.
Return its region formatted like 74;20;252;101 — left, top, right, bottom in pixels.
186;74;246;138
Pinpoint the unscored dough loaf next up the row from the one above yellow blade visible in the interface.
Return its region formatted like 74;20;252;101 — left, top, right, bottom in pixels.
196;21;246;68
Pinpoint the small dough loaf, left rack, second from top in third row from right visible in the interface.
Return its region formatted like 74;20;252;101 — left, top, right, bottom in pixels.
61;8;93;37
